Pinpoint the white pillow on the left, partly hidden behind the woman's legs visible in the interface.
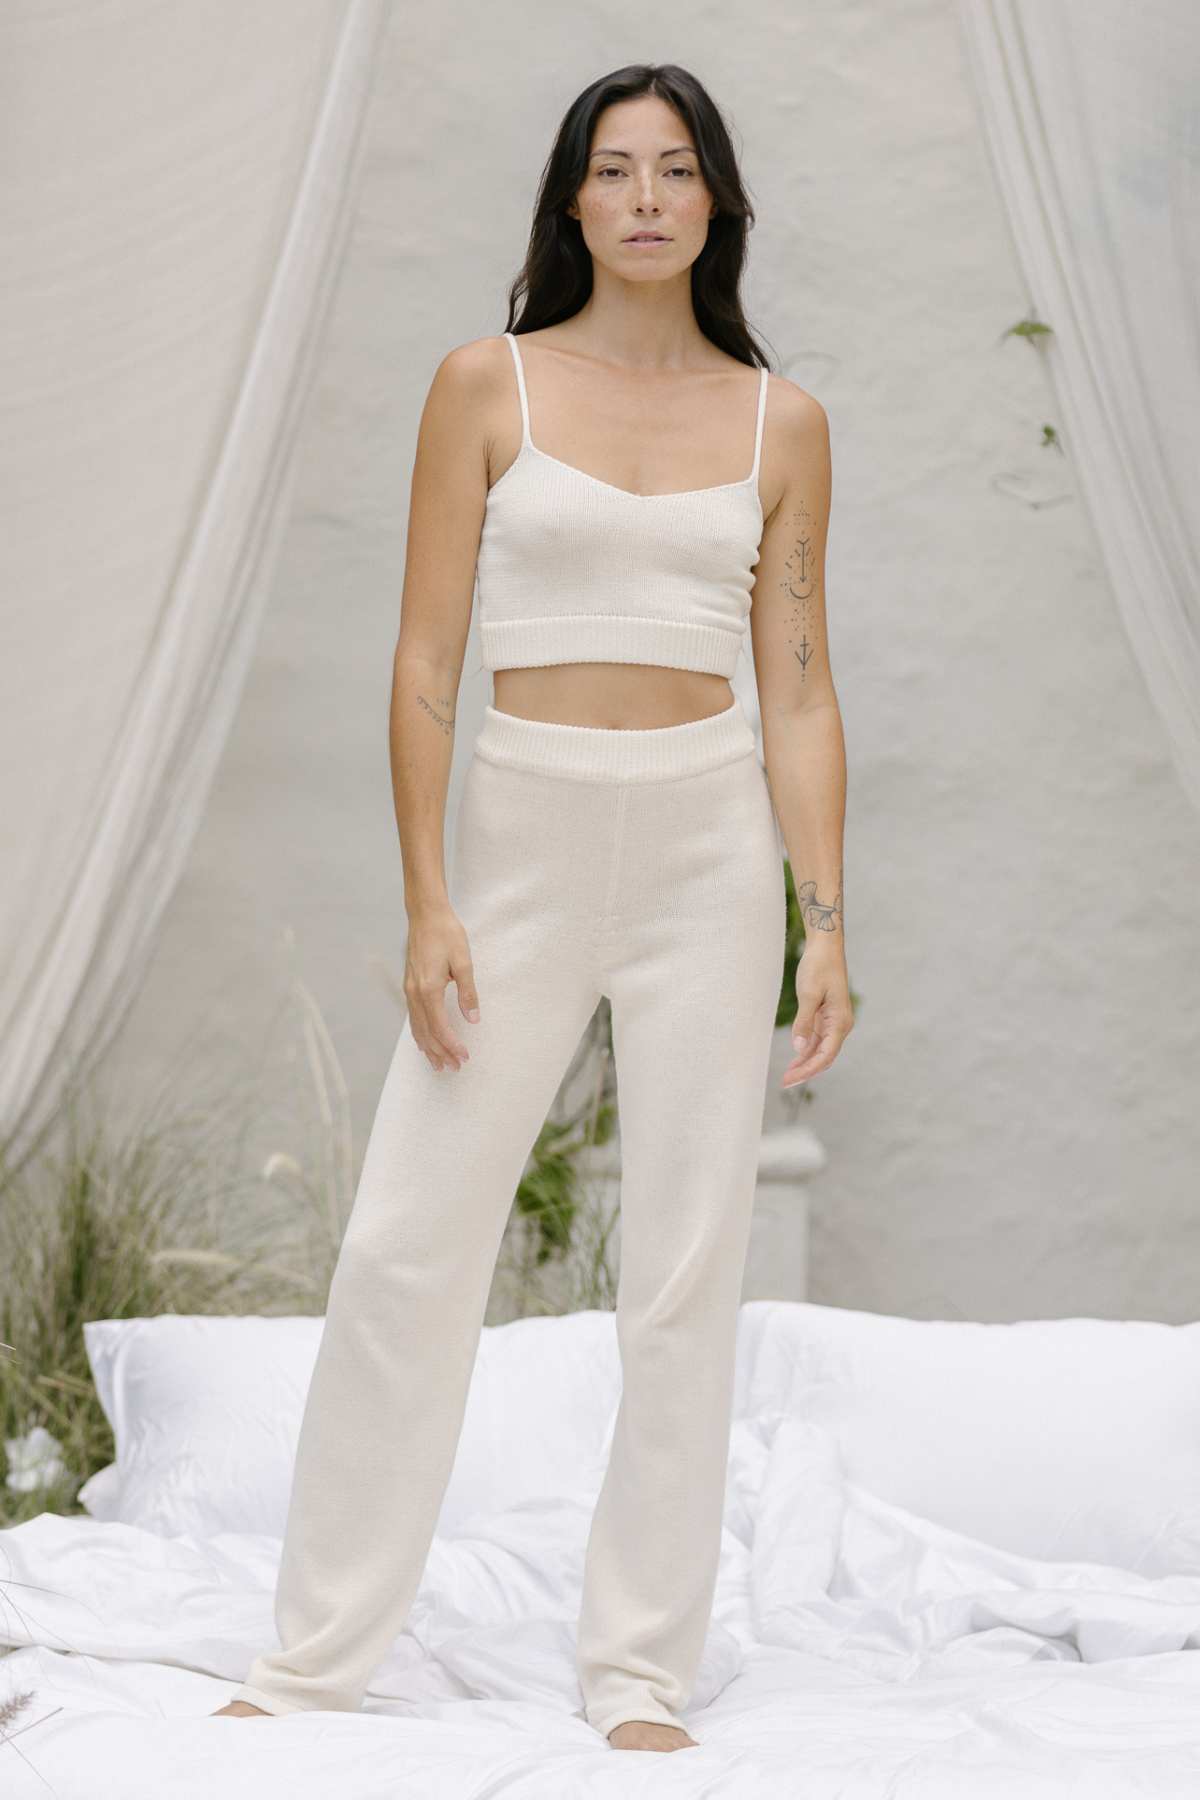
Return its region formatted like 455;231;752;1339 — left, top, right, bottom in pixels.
81;1312;619;1537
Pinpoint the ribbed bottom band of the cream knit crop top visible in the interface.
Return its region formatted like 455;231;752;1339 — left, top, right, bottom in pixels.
479;612;745;675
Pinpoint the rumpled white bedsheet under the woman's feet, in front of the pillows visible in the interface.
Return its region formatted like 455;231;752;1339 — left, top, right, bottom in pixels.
0;1413;1200;1800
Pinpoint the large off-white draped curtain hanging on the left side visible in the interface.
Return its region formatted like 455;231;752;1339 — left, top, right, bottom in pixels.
0;0;387;1159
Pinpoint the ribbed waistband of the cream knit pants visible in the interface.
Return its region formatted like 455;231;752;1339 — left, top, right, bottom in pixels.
475;697;757;781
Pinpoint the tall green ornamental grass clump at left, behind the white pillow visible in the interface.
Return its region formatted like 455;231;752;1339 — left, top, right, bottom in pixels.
0;981;376;1525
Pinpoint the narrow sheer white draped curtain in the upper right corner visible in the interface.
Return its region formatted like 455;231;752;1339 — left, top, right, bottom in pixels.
959;0;1200;808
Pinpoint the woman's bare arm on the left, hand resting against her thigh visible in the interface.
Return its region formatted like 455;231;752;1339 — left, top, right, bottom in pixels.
389;338;497;1069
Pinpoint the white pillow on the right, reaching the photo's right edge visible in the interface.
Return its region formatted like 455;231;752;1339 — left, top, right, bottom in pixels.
738;1300;1200;1577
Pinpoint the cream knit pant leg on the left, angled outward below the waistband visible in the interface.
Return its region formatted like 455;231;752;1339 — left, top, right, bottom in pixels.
232;760;599;1712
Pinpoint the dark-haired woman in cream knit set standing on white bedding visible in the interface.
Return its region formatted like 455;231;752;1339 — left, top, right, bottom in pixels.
221;65;851;1750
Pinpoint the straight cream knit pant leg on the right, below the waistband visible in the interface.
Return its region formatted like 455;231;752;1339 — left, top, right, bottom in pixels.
578;756;786;1735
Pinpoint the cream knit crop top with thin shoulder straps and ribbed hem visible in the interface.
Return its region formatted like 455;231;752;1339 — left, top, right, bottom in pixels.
477;331;766;675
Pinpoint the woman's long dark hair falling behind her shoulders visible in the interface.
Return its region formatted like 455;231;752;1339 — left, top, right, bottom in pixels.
506;63;768;367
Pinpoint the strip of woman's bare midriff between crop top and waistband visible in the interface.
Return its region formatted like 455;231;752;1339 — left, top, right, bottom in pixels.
491;662;734;731
